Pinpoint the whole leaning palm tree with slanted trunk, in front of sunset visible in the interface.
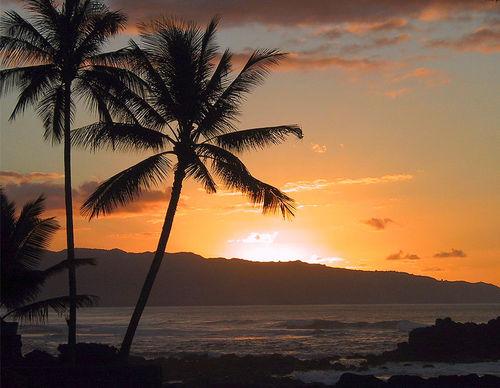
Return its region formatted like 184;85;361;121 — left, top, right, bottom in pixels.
73;19;302;356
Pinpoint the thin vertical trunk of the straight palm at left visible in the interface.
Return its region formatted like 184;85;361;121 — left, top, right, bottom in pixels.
64;82;76;362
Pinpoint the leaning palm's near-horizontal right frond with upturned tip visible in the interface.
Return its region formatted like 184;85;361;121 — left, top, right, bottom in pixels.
211;124;303;152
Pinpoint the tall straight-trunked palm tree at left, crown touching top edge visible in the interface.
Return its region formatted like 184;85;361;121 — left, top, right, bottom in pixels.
0;0;140;349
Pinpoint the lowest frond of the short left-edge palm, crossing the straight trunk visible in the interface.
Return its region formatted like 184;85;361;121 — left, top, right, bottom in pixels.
2;295;99;323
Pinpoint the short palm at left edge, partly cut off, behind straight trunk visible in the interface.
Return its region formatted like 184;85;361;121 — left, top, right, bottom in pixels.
0;188;96;322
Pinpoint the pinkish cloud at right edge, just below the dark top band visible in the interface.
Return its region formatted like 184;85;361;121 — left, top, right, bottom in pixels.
427;27;500;54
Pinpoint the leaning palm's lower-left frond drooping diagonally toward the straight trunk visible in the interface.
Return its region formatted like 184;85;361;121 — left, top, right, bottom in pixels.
81;152;171;218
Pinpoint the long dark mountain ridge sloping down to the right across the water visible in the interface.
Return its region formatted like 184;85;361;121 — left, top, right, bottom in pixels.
40;249;500;306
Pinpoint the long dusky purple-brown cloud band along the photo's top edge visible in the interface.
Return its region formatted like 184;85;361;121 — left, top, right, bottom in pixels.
112;0;493;27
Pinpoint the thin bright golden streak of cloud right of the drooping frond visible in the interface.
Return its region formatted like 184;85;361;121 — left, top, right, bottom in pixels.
282;174;413;193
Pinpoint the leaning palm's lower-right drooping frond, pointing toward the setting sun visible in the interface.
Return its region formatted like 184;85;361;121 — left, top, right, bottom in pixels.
197;143;295;218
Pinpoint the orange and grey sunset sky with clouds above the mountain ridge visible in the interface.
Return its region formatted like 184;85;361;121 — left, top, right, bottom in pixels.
0;0;500;285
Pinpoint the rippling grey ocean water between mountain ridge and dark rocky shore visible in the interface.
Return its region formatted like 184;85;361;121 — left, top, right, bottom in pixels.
20;304;500;358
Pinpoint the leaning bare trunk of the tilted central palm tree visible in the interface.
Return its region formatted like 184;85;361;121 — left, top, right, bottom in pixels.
120;167;186;358
